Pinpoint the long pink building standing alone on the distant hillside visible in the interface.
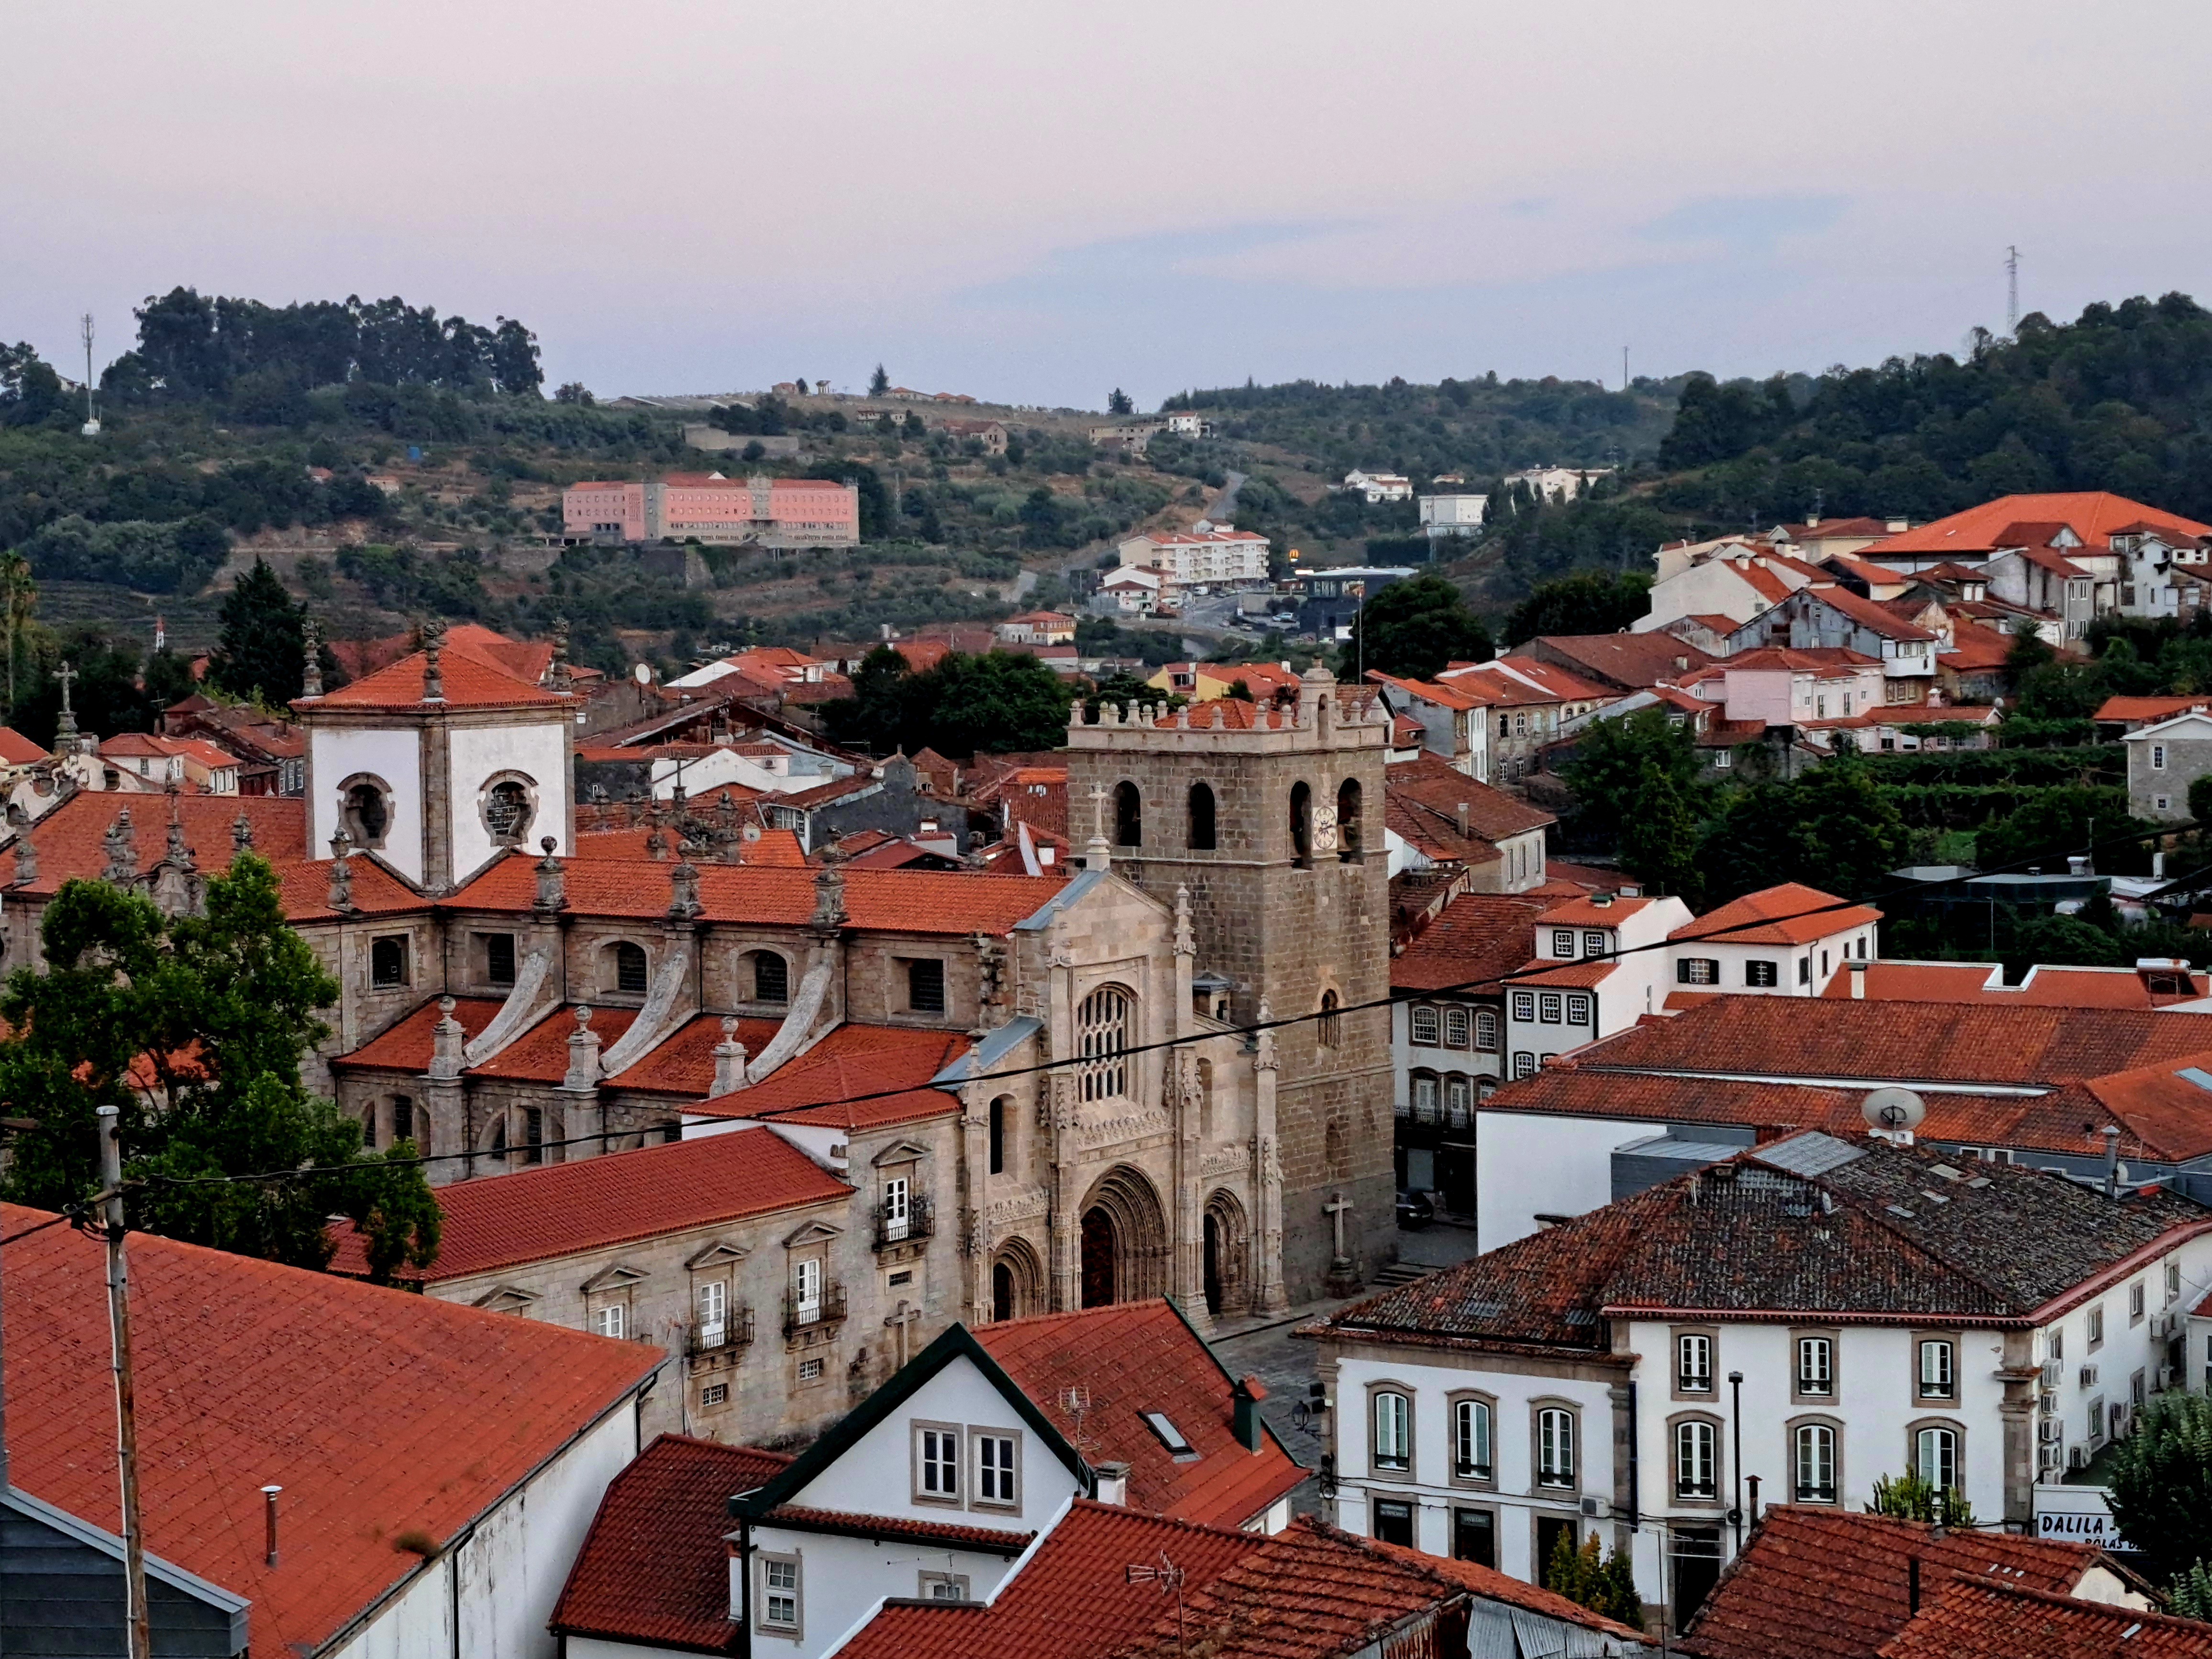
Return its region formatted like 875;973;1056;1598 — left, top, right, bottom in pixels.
562;474;861;546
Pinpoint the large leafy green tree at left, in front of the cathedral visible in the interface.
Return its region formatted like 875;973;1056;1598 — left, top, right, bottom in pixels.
0;854;440;1279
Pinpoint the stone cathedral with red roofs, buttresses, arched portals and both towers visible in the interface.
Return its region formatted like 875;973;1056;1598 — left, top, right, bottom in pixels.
0;630;1394;1353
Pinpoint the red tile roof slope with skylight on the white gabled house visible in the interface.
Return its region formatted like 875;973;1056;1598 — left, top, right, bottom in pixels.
975;1301;1305;1528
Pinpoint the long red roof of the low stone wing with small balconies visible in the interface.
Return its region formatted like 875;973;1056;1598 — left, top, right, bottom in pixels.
332;1128;852;1285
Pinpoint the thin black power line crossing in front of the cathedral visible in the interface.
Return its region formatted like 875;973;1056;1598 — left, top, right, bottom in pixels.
135;821;2212;1188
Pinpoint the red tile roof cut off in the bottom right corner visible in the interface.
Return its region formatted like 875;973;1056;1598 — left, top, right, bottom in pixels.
1880;1577;2212;1659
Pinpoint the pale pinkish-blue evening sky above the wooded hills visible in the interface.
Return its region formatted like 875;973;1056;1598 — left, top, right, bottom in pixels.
0;0;2212;409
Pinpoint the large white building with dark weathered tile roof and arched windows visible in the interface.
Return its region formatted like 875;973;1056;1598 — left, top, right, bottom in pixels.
1318;1130;2212;1628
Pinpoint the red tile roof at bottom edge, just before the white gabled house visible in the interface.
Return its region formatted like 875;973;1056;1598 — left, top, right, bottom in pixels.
836;1500;1259;1659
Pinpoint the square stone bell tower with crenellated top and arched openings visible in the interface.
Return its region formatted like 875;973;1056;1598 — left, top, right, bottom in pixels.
1068;666;1396;1303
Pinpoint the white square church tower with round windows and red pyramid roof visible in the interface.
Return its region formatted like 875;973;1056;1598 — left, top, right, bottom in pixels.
292;624;579;894
